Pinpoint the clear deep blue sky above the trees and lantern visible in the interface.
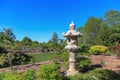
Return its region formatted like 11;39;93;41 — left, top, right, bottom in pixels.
0;0;120;42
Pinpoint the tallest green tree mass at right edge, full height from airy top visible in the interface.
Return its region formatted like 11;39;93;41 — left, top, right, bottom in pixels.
99;10;120;46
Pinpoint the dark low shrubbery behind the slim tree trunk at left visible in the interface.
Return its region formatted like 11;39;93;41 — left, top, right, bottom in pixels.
0;53;31;67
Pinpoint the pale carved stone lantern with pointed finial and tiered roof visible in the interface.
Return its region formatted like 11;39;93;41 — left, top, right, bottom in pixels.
63;21;82;76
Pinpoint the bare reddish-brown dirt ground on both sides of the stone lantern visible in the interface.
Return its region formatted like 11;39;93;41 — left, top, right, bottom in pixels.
0;55;120;73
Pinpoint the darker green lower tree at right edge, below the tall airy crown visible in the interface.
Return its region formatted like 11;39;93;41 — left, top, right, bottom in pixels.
99;25;120;46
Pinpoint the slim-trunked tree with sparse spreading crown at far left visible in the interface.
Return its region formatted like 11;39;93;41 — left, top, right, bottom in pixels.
1;28;17;70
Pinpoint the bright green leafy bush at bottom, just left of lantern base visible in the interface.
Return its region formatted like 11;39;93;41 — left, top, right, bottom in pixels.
38;64;60;80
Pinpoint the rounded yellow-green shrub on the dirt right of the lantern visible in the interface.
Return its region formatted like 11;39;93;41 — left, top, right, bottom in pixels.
89;45;108;54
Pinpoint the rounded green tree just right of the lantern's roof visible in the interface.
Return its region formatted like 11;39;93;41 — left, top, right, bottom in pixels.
82;17;102;44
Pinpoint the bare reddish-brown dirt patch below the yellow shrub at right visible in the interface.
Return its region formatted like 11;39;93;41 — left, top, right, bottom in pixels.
91;55;120;73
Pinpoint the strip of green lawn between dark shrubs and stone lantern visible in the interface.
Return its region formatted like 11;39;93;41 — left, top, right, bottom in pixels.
29;53;58;62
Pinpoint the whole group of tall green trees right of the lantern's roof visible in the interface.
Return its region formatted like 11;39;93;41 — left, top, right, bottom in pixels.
78;10;120;46
